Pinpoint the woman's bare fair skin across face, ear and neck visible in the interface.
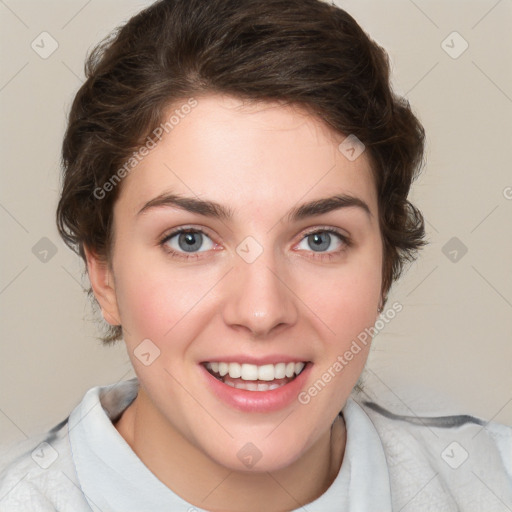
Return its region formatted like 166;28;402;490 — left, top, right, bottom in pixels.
86;95;382;512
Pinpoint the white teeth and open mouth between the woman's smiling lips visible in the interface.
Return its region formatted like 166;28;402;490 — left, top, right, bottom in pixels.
203;361;308;391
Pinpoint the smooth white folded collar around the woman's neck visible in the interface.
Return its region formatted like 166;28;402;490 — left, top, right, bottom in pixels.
69;378;391;512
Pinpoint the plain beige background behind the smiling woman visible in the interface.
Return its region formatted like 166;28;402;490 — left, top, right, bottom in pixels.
0;0;512;442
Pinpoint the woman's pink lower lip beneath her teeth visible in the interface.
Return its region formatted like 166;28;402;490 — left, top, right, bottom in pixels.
199;363;312;412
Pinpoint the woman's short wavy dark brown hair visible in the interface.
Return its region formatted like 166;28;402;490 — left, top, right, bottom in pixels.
57;0;426;342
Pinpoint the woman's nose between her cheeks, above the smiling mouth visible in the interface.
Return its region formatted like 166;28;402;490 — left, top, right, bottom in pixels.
223;251;298;338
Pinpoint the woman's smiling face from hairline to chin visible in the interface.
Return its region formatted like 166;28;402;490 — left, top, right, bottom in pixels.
90;95;382;471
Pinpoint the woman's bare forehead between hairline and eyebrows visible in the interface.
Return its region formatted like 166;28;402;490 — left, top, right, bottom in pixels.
114;95;376;220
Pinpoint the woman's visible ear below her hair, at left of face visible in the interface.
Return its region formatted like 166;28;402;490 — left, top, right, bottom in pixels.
84;245;121;325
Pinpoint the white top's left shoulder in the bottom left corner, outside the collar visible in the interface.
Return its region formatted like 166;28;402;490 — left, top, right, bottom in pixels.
0;419;90;512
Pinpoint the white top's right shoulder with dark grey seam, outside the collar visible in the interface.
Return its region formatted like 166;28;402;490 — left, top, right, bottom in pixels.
354;395;512;511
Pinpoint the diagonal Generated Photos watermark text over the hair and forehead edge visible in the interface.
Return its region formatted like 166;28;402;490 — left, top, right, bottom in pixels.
93;98;198;200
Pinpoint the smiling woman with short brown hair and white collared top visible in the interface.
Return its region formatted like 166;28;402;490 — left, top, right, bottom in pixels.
0;0;512;512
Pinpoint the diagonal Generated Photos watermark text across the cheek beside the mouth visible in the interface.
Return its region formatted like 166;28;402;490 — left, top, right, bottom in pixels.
297;302;403;405
